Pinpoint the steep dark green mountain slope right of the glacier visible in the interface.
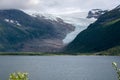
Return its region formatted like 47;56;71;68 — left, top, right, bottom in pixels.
65;5;120;53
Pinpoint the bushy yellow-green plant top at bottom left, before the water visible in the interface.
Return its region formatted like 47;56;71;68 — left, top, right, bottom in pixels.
9;72;28;80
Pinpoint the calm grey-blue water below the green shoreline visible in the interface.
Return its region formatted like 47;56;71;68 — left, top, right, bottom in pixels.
0;56;120;80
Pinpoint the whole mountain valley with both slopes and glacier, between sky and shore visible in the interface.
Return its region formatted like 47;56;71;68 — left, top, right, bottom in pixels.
0;6;120;55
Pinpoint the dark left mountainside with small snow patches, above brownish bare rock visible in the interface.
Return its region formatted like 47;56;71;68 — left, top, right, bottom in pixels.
0;9;74;51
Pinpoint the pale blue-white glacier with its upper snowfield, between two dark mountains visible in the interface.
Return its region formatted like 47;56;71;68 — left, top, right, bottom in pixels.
28;12;96;44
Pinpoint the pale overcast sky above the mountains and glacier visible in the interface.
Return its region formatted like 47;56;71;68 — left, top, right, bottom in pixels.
0;0;120;14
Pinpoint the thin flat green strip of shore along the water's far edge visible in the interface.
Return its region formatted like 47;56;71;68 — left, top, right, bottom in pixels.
0;52;120;56
